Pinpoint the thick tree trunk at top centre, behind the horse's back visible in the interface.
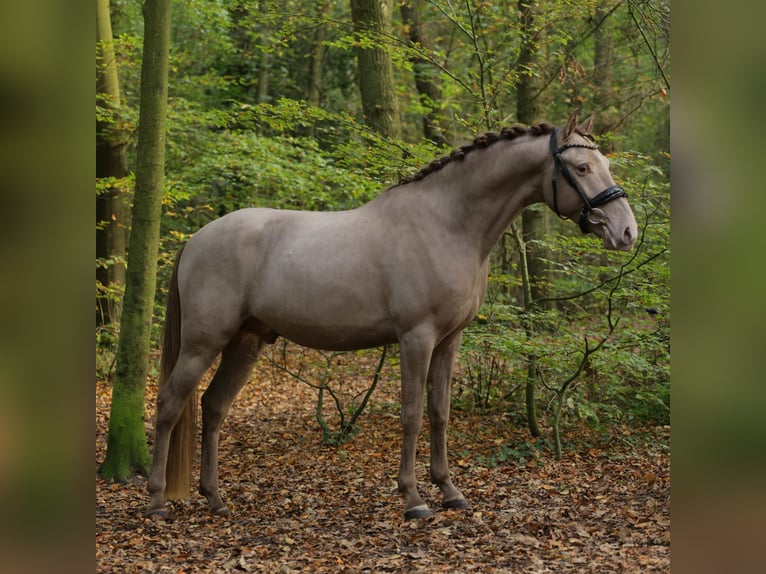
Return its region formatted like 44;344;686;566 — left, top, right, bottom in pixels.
351;0;401;138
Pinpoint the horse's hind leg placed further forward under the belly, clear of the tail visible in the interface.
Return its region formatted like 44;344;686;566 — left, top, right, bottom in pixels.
199;331;263;514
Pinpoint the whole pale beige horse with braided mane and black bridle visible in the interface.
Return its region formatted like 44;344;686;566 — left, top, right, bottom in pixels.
147;111;637;519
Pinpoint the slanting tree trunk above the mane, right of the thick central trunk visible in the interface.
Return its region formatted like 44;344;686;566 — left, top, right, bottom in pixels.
401;0;452;146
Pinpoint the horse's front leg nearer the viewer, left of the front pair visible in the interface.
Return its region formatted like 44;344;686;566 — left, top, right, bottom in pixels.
398;329;433;519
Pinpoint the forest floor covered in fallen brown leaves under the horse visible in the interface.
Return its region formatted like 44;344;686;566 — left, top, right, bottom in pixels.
96;348;670;574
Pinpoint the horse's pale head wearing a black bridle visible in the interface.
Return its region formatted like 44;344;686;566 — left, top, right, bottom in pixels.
543;111;638;251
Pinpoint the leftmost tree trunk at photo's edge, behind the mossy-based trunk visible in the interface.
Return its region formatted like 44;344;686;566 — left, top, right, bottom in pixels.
96;0;128;325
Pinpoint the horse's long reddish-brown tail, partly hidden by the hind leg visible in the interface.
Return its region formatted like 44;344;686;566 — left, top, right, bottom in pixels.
159;246;199;500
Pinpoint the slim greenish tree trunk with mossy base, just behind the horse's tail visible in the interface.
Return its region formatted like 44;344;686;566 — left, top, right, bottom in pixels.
101;0;171;480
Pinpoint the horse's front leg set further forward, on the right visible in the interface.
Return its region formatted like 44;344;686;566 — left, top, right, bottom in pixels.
428;333;468;508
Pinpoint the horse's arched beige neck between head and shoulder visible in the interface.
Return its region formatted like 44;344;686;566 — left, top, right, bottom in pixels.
424;136;548;260
